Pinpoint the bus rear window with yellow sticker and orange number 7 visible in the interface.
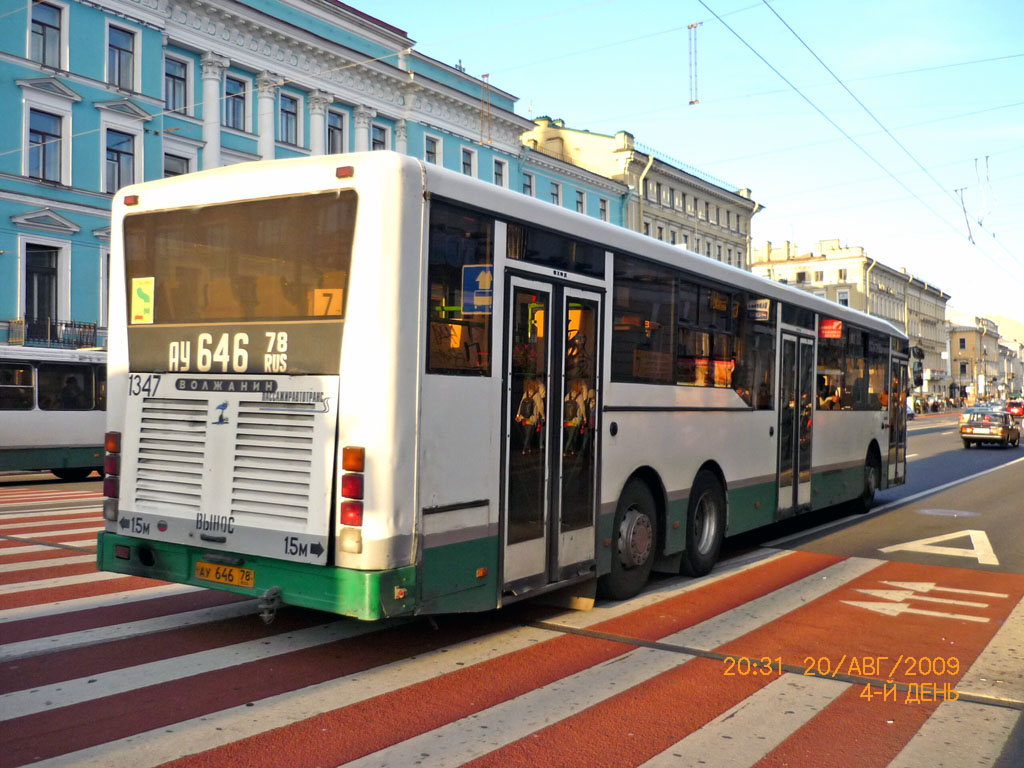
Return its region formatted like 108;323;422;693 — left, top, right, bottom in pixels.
124;190;356;325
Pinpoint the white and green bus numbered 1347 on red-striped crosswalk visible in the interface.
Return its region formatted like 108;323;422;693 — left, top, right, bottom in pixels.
97;152;908;620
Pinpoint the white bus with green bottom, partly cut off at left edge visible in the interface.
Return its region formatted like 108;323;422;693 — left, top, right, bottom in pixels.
0;345;106;480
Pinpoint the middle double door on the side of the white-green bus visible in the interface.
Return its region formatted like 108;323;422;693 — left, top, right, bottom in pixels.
776;332;814;517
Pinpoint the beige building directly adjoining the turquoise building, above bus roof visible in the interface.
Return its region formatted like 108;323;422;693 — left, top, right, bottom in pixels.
522;118;762;269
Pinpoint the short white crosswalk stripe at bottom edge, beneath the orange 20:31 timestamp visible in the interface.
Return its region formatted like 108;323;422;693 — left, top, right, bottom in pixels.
641;675;847;768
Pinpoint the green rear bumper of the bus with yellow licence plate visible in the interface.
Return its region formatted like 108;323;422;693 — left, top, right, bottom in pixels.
96;531;417;621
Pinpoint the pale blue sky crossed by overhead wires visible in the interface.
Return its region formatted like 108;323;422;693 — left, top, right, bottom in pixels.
348;0;1024;341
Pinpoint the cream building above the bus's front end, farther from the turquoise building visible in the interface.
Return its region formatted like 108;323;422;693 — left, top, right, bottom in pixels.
751;240;950;397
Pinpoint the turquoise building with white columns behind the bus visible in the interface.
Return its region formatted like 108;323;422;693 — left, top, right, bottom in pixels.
0;0;630;346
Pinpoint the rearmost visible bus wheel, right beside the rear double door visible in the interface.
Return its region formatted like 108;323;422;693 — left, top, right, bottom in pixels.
597;480;657;600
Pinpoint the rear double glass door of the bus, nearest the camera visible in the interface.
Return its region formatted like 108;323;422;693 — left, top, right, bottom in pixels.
502;278;601;594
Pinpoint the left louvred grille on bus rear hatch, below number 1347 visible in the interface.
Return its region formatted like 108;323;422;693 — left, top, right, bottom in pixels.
135;397;209;513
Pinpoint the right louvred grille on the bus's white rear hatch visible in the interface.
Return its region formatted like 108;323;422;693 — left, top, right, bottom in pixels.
231;401;317;523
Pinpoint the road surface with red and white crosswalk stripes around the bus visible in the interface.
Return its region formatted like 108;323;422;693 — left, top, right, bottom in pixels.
0;415;1024;768
